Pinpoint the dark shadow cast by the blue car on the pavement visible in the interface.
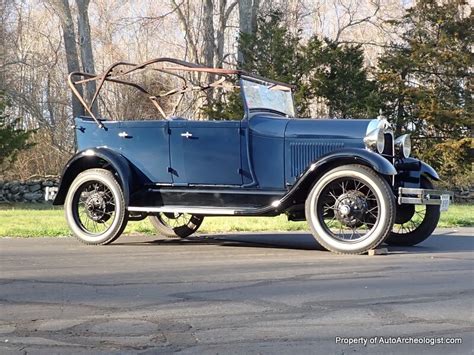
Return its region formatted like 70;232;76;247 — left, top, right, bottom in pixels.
114;232;474;254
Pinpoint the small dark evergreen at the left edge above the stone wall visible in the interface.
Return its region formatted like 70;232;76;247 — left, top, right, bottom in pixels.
0;92;30;168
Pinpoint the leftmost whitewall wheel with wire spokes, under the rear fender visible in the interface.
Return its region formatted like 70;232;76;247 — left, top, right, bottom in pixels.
64;169;128;245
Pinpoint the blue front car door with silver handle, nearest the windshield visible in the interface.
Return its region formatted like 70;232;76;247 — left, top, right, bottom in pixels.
169;120;242;185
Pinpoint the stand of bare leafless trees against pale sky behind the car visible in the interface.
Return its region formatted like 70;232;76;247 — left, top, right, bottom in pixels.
0;0;412;179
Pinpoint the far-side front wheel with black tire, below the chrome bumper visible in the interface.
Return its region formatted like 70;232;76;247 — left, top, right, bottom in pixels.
385;178;441;246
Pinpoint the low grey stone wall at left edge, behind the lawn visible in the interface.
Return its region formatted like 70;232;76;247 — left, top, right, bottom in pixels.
0;177;59;203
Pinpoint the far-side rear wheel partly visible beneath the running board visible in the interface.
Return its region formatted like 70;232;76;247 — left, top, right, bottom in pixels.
148;212;204;238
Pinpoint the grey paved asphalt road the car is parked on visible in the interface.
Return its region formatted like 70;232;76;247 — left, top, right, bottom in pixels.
0;229;474;355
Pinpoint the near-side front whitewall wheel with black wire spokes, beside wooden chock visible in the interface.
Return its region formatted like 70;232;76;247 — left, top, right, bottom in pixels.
305;165;395;254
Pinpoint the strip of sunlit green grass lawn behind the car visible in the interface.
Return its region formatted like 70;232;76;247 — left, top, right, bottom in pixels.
0;204;474;237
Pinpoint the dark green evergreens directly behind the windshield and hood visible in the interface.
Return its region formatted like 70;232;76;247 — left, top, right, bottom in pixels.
206;11;380;119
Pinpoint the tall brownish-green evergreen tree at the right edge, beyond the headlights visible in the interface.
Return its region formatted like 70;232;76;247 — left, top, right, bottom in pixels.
377;0;474;188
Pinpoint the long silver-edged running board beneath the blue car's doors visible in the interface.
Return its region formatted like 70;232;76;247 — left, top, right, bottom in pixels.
127;206;280;216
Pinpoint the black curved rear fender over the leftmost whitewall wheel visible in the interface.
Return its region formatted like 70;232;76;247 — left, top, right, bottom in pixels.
53;147;133;206
